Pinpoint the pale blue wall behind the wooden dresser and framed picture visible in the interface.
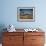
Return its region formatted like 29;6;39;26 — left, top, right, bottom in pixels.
0;0;46;44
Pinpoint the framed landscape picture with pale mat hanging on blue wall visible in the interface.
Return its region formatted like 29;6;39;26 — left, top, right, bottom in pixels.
17;7;35;22
